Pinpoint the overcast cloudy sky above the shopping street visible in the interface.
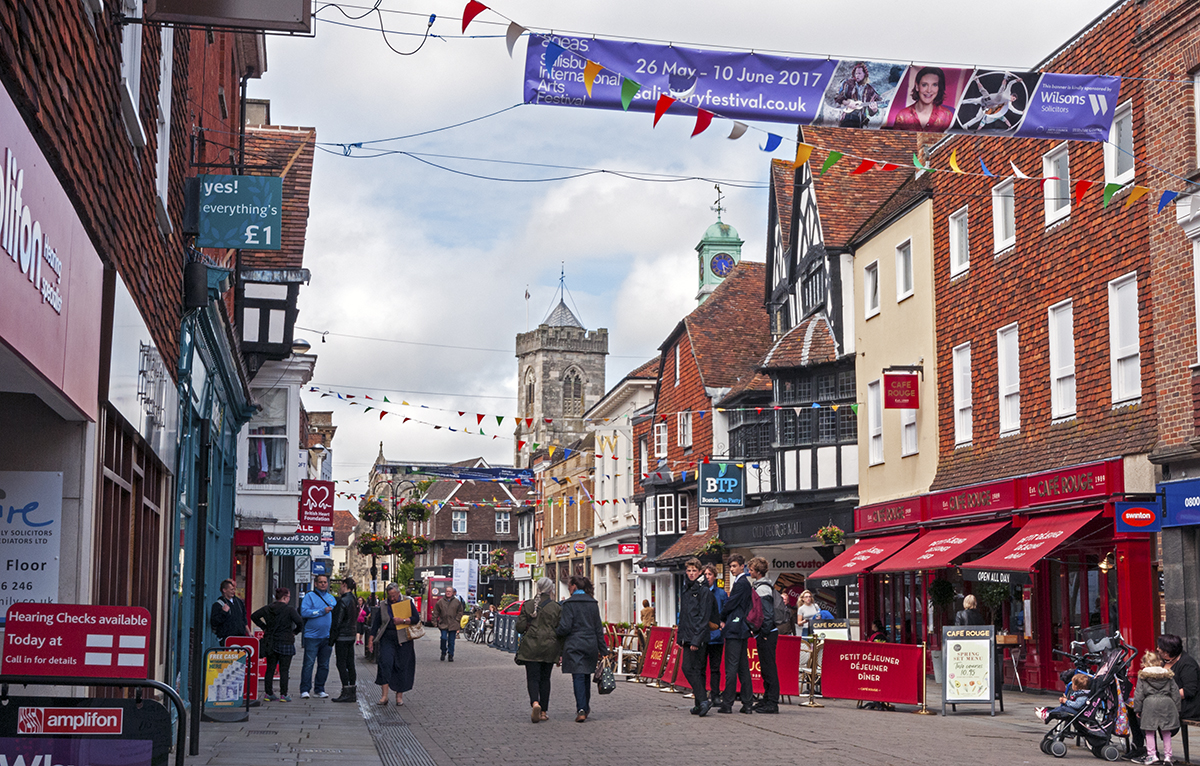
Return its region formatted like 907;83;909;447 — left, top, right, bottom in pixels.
250;0;1109;509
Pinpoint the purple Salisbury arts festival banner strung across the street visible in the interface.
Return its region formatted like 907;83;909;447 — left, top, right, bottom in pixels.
524;35;1121;140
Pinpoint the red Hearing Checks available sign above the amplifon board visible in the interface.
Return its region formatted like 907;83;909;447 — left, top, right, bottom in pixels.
0;603;150;678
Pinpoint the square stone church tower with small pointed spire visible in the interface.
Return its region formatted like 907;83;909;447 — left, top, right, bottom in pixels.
512;299;608;468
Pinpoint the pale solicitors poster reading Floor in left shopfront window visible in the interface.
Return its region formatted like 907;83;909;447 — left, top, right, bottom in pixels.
0;471;62;624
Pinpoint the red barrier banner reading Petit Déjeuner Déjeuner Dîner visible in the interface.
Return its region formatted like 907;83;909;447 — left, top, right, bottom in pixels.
821;641;925;705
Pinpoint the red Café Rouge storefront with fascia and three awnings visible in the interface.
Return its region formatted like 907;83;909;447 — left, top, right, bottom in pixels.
809;459;1158;689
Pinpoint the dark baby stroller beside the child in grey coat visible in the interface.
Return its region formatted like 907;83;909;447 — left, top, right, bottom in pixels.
1042;633;1136;761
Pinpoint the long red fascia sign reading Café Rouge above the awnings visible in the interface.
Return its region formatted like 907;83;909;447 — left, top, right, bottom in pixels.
854;460;1123;532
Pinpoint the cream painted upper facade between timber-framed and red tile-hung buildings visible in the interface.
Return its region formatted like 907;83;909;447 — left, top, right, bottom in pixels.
854;194;937;505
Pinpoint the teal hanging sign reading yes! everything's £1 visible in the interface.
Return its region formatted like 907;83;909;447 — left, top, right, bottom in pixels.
196;175;283;250
